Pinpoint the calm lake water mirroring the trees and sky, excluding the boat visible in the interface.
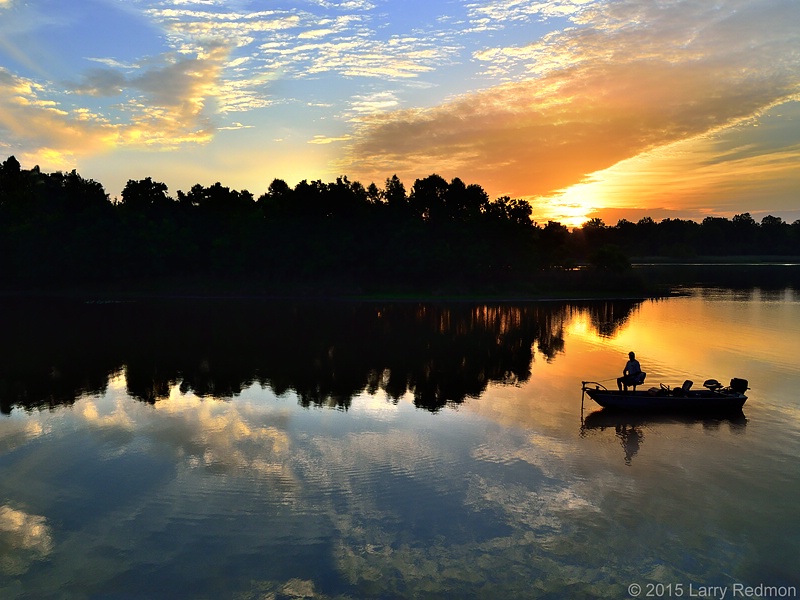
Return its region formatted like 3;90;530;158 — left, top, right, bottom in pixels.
0;288;800;599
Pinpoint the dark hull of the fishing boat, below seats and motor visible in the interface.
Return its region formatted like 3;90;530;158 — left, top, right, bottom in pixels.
586;388;747;413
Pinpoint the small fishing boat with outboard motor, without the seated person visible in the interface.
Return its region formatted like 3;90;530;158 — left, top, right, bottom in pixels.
582;378;749;413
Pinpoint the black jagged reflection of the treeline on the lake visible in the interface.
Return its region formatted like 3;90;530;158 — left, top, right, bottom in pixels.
0;300;636;413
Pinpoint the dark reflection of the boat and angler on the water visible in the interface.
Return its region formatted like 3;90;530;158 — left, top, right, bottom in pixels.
580;409;747;466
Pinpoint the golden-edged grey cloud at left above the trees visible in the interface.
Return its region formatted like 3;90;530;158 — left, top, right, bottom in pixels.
0;38;238;168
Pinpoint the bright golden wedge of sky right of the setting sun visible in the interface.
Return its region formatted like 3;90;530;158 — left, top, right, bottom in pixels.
553;102;800;224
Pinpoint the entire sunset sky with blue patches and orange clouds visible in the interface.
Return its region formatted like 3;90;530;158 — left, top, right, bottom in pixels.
0;0;800;225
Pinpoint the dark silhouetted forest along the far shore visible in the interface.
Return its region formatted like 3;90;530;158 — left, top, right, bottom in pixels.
0;156;800;294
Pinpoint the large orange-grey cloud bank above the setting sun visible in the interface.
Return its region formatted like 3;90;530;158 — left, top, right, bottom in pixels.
348;0;800;196
